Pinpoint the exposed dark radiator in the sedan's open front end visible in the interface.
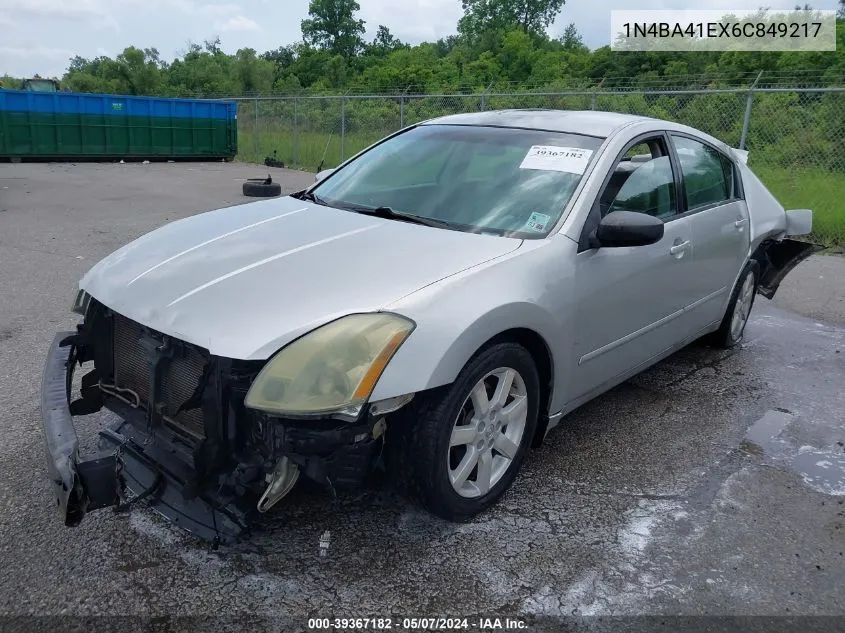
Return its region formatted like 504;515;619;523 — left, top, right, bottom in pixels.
114;314;208;440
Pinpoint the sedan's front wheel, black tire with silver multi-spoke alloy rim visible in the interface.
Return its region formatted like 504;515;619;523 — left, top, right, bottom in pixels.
387;343;540;521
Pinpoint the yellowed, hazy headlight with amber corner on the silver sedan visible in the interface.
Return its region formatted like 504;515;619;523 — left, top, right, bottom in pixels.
244;313;414;417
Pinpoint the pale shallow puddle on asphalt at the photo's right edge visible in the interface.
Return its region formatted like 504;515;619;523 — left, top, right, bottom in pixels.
740;410;845;495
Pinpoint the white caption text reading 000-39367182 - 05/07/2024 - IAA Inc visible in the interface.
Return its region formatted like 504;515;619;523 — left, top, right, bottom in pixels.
308;616;528;631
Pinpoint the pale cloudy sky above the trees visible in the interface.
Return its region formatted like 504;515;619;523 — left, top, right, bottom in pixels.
0;0;837;77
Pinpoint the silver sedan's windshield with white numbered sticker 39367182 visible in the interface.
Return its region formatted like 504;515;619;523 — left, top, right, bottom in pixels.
312;125;602;238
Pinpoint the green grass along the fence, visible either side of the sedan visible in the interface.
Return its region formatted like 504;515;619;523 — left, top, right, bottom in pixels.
238;126;845;248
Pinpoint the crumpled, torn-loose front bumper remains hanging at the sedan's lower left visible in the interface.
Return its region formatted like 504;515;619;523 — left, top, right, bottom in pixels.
41;332;247;544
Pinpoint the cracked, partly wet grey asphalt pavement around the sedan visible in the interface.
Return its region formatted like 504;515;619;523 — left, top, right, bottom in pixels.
0;163;845;618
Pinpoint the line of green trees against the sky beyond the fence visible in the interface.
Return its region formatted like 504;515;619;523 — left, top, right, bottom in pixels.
3;0;845;96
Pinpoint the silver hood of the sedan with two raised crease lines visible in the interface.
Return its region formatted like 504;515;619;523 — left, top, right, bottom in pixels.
80;197;521;360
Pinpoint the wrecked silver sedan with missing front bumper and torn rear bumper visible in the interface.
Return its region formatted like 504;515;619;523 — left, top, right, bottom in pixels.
42;110;816;541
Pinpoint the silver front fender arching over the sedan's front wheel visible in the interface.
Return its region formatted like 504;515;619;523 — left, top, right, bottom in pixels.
372;238;577;407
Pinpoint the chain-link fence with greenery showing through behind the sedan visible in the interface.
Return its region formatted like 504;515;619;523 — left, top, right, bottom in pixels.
232;86;845;247
